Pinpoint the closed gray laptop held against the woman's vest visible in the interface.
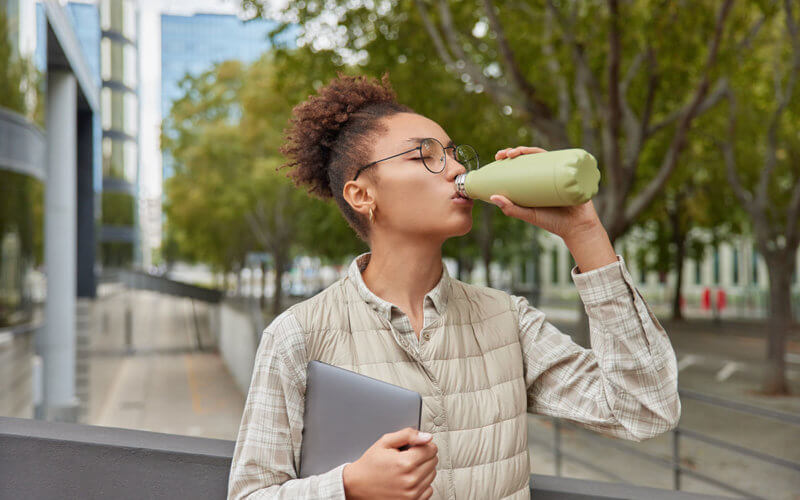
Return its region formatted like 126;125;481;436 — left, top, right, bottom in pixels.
299;360;422;477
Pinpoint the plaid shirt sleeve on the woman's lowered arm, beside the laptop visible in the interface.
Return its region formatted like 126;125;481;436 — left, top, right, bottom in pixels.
228;311;347;500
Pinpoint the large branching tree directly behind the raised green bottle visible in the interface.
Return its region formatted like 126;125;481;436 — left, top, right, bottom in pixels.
253;0;752;241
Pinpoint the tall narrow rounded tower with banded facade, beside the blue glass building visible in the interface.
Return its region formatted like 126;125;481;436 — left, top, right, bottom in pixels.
99;0;141;267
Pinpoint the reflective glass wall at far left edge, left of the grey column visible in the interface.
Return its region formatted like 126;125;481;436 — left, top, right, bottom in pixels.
0;0;45;328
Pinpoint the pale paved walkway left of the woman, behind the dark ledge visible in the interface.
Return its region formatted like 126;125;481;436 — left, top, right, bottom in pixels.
87;291;245;440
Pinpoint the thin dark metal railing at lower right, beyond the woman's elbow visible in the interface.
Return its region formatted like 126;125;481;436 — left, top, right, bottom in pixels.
530;389;800;499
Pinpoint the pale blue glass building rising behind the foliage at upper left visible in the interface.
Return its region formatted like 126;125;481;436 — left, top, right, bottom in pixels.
161;14;282;179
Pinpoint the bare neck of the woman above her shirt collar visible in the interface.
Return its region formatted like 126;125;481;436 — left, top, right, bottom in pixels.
362;231;443;314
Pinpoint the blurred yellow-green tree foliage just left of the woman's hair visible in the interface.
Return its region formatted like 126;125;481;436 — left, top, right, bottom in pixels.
162;56;363;270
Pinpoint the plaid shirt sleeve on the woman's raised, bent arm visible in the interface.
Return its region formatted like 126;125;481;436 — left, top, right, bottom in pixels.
512;255;681;441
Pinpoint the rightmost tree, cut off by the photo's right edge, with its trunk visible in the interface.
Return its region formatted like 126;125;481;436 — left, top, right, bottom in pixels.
719;0;800;394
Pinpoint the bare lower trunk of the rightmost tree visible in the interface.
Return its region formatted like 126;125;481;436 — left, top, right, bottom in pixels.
762;254;797;395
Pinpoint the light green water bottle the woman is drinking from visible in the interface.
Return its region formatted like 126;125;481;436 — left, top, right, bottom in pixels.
455;148;600;207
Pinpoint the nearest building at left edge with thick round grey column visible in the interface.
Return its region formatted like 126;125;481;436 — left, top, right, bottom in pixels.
0;0;100;421
